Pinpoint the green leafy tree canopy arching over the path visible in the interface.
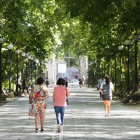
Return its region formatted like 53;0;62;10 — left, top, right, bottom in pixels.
0;0;140;89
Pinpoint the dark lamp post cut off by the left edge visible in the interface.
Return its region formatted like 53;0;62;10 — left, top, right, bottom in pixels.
0;35;3;95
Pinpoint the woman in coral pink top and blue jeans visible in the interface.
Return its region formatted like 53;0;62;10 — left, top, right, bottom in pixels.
53;78;69;132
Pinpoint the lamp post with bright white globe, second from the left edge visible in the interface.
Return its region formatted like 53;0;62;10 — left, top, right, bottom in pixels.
8;43;13;93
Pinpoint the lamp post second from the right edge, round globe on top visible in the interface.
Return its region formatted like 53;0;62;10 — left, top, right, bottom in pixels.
125;40;131;94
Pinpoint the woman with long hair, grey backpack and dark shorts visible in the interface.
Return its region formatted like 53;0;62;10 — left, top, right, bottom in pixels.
100;76;114;117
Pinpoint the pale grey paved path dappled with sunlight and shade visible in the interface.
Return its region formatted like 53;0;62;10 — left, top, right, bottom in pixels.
0;84;140;140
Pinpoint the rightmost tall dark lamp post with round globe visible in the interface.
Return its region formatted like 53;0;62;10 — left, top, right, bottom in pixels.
133;34;139;88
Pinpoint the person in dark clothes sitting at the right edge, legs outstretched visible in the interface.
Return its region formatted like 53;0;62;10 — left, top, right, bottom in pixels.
122;85;140;103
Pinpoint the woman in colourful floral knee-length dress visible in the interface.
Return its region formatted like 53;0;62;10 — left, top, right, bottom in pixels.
29;77;49;133
